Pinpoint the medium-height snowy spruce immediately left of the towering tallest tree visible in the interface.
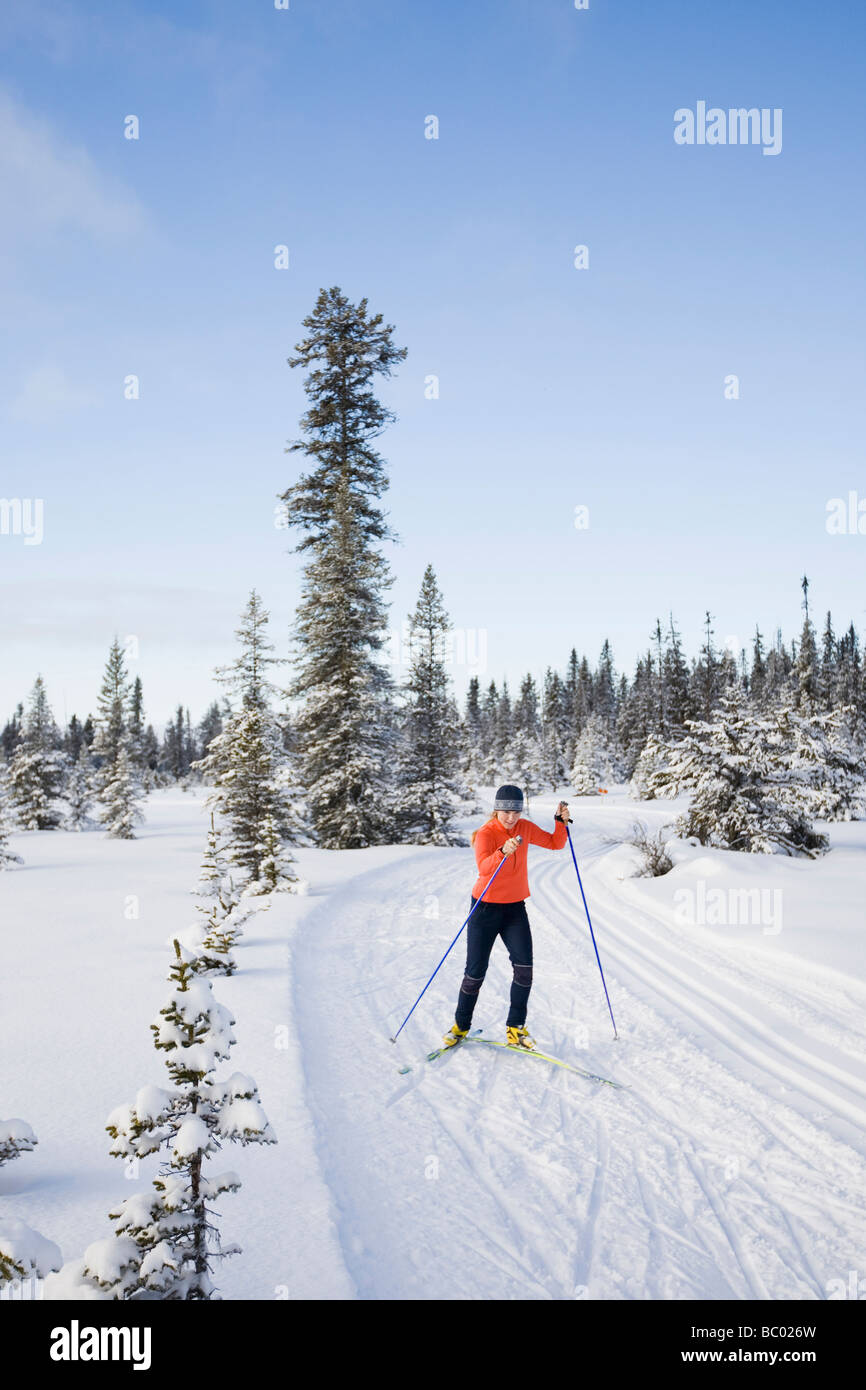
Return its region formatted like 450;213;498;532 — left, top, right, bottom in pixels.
193;589;303;891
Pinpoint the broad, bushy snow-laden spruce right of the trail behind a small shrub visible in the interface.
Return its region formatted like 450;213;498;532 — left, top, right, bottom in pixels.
636;685;827;858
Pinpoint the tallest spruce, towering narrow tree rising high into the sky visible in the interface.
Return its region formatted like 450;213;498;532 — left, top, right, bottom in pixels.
282;286;406;849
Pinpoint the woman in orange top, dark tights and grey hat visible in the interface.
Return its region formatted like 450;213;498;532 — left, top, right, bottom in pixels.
443;785;570;1051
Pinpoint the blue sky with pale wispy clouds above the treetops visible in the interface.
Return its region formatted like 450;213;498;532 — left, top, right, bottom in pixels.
0;0;866;724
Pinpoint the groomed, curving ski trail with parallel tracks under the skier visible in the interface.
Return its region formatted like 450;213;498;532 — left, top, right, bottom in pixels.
292;830;866;1300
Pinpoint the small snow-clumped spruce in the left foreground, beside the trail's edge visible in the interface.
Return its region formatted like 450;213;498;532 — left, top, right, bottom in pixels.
59;942;277;1301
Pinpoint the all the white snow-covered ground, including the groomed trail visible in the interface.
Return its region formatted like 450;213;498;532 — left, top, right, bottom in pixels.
0;791;866;1300
